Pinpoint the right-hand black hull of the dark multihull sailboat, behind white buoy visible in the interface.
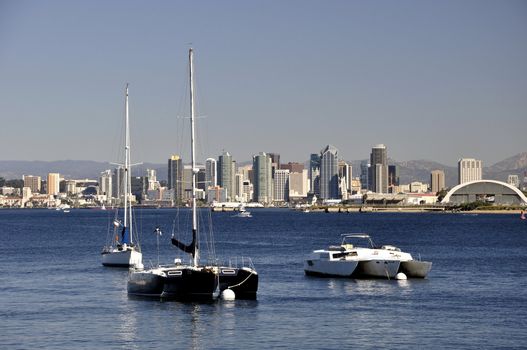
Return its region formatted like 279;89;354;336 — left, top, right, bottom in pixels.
219;267;258;300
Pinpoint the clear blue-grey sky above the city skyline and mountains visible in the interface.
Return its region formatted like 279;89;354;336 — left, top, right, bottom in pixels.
0;0;527;166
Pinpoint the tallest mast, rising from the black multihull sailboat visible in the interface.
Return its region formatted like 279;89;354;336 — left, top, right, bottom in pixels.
189;48;199;266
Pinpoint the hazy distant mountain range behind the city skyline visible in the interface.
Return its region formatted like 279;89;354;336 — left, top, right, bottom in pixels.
0;152;527;187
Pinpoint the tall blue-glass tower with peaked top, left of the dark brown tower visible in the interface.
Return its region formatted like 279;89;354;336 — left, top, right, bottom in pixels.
320;145;339;199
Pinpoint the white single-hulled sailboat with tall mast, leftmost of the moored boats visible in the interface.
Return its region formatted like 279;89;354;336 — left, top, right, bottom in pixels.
101;84;143;267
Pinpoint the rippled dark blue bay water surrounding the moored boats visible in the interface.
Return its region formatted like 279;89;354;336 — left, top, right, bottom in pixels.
0;209;527;349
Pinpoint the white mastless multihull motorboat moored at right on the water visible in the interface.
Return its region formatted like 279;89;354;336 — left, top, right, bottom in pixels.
304;233;432;279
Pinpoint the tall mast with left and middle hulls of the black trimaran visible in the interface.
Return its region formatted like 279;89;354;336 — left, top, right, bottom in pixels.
128;49;220;300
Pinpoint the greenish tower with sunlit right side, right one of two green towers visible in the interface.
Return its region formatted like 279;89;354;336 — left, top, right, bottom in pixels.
253;152;273;203
